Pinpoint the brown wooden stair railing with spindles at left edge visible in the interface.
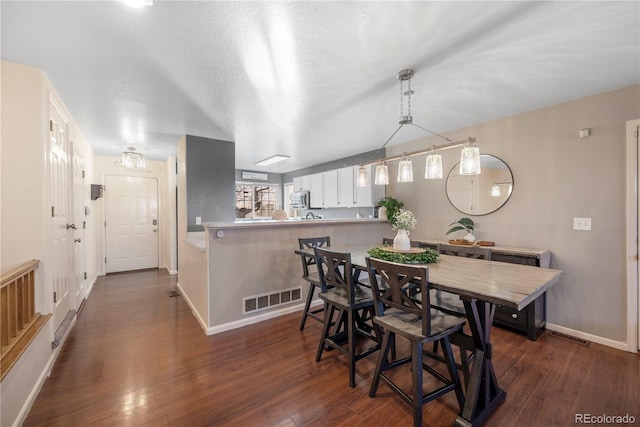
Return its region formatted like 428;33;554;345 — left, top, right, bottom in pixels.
0;259;51;381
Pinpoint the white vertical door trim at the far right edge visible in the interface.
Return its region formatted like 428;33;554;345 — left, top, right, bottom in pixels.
625;119;640;353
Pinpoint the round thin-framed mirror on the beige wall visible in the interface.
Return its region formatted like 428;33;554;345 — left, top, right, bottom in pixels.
447;154;513;215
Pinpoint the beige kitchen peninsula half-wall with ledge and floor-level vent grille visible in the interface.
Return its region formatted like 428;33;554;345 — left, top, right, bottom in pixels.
178;218;392;335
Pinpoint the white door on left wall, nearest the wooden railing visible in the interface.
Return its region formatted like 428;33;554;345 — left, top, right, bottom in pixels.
49;100;73;328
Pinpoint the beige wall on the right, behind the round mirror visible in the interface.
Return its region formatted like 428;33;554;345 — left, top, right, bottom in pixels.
387;86;640;348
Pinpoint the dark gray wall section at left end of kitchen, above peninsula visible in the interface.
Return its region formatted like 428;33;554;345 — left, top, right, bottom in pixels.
186;135;236;231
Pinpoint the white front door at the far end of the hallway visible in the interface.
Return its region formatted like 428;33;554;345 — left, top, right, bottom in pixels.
104;176;159;273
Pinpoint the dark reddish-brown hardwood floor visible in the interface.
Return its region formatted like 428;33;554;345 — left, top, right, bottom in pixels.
24;271;640;427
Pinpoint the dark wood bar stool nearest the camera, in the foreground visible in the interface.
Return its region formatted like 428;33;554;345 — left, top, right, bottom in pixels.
367;258;465;427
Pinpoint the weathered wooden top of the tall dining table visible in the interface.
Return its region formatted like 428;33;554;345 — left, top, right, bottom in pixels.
296;246;562;310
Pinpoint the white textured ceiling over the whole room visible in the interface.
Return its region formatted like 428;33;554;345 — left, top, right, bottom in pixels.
0;0;640;172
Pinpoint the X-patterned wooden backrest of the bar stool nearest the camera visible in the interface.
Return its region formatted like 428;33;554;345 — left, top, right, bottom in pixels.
367;257;431;337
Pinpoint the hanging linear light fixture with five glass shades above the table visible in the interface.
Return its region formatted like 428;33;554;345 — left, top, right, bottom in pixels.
357;69;480;187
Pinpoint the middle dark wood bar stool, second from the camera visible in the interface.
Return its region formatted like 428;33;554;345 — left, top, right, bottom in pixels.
314;247;382;388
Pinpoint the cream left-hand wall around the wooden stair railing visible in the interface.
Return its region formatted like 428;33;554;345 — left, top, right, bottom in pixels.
0;61;95;426
